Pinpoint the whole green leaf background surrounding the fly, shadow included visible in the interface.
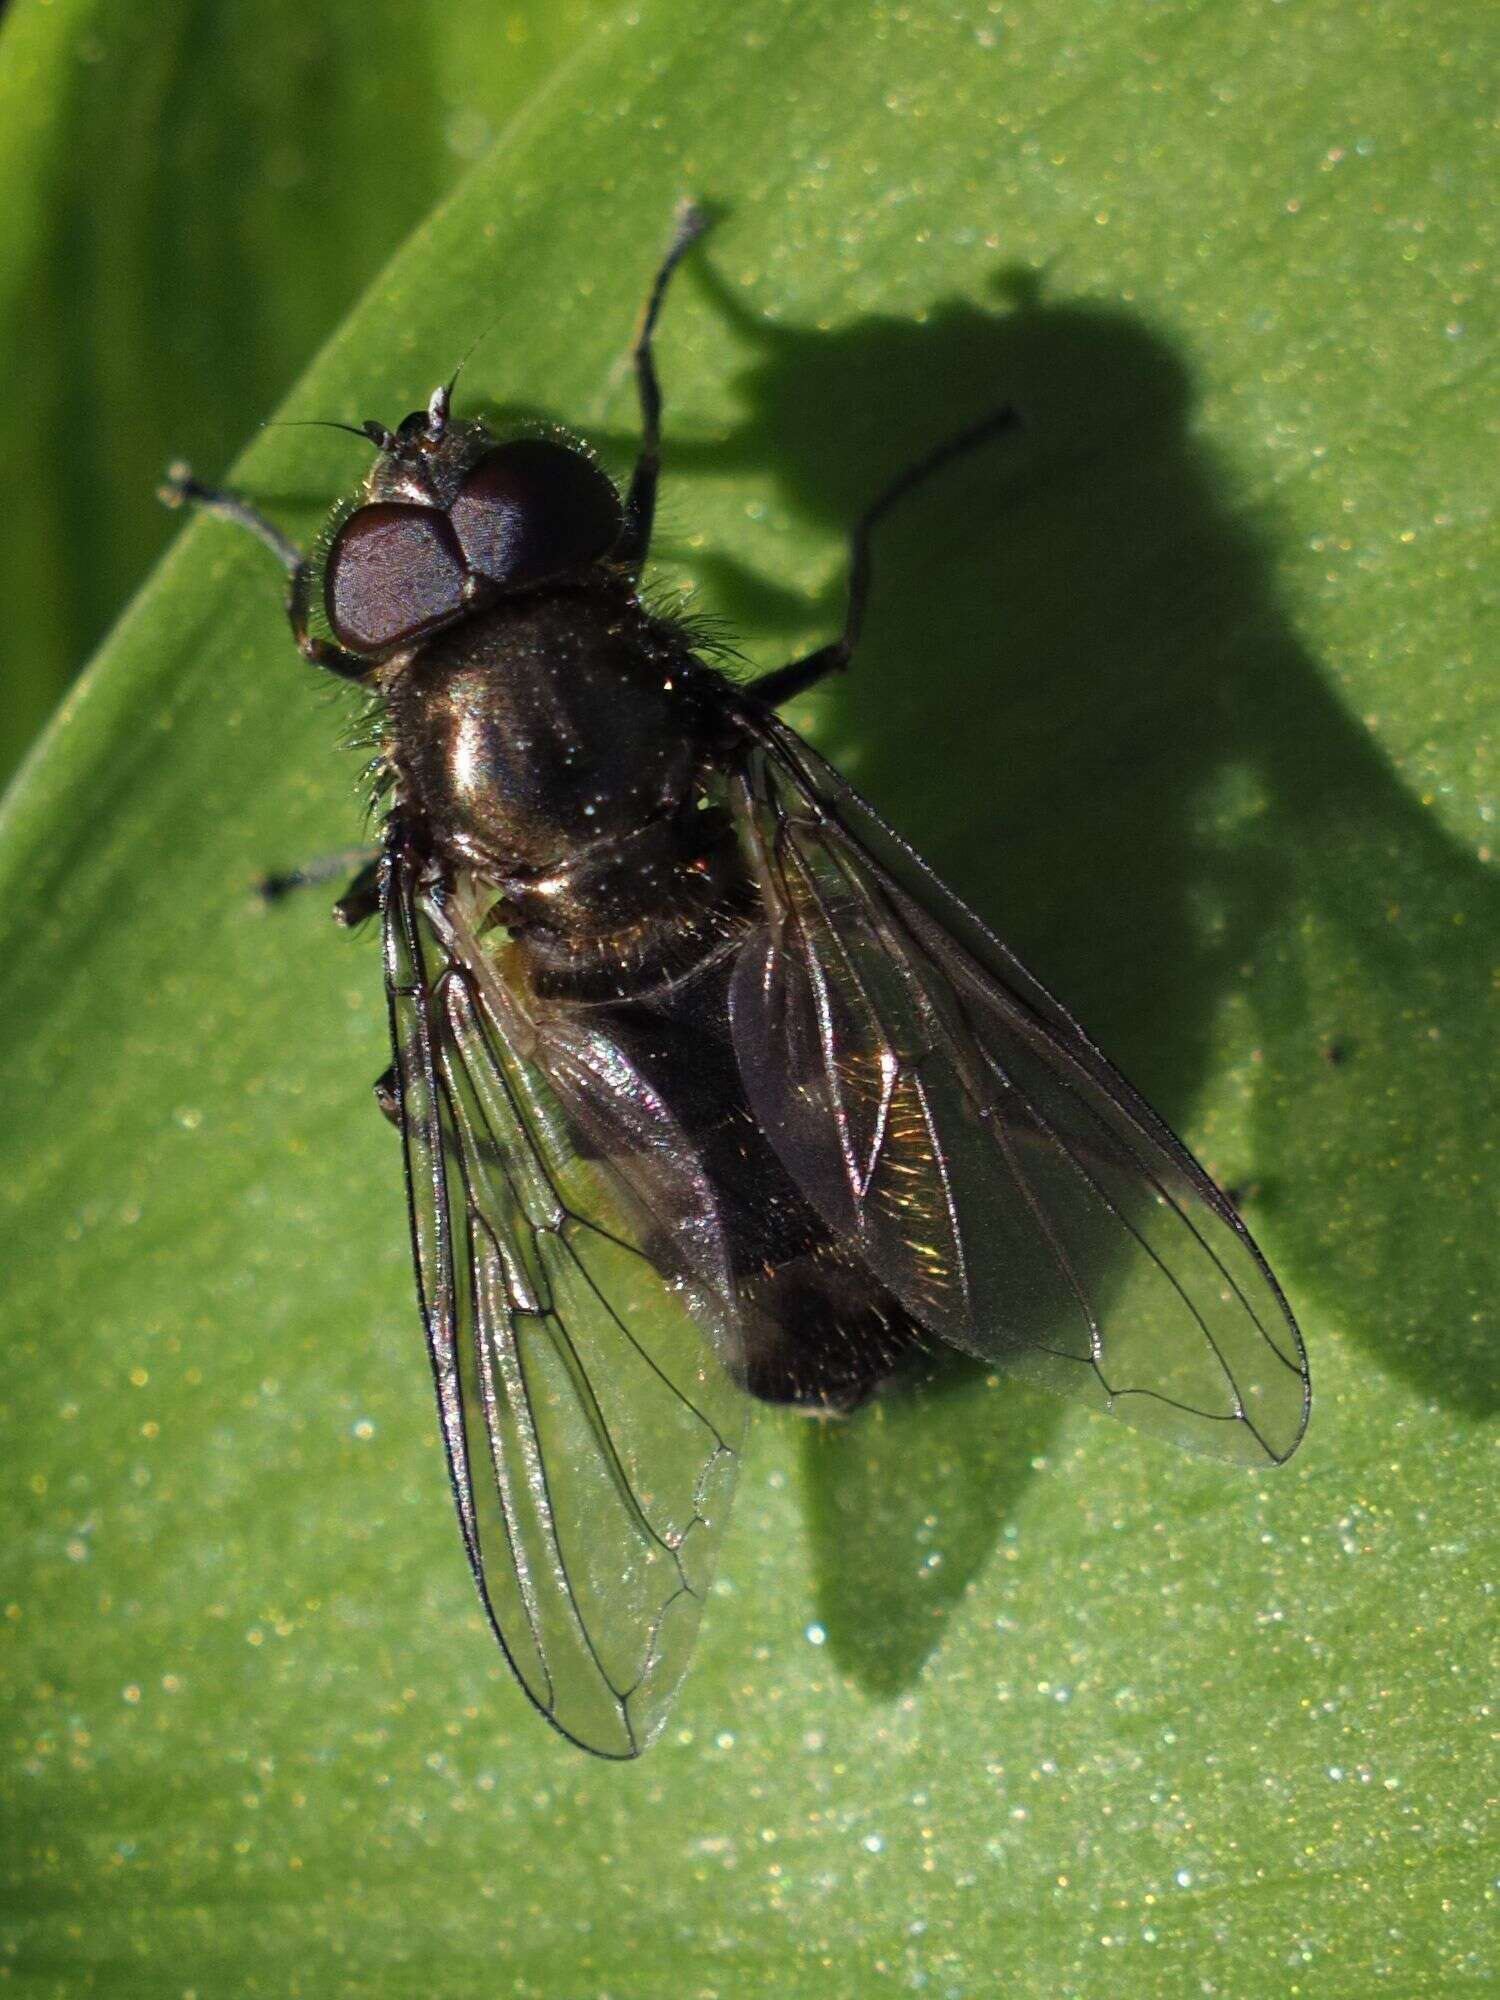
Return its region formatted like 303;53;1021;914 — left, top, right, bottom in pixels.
0;0;1500;2000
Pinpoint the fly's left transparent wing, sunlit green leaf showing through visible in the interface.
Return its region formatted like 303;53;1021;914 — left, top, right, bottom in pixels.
384;842;746;1758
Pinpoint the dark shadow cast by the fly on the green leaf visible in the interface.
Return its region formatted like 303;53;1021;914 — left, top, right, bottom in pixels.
572;242;1500;1694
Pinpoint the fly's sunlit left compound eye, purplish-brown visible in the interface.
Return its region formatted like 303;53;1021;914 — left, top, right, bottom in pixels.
324;502;464;652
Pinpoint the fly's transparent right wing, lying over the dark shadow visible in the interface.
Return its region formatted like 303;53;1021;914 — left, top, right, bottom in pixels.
730;704;1308;1464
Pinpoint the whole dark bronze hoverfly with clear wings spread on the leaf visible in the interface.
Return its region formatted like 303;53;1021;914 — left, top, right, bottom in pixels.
164;208;1308;1758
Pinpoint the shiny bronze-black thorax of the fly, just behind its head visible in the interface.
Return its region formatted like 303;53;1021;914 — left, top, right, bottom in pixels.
384;586;704;876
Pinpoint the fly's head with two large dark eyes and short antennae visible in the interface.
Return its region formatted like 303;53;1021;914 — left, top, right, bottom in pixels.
322;386;624;660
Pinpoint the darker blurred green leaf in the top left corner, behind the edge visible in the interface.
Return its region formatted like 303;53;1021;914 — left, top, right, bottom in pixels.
0;0;604;776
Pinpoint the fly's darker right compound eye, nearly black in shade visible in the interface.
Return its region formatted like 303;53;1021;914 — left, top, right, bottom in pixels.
448;438;620;586
